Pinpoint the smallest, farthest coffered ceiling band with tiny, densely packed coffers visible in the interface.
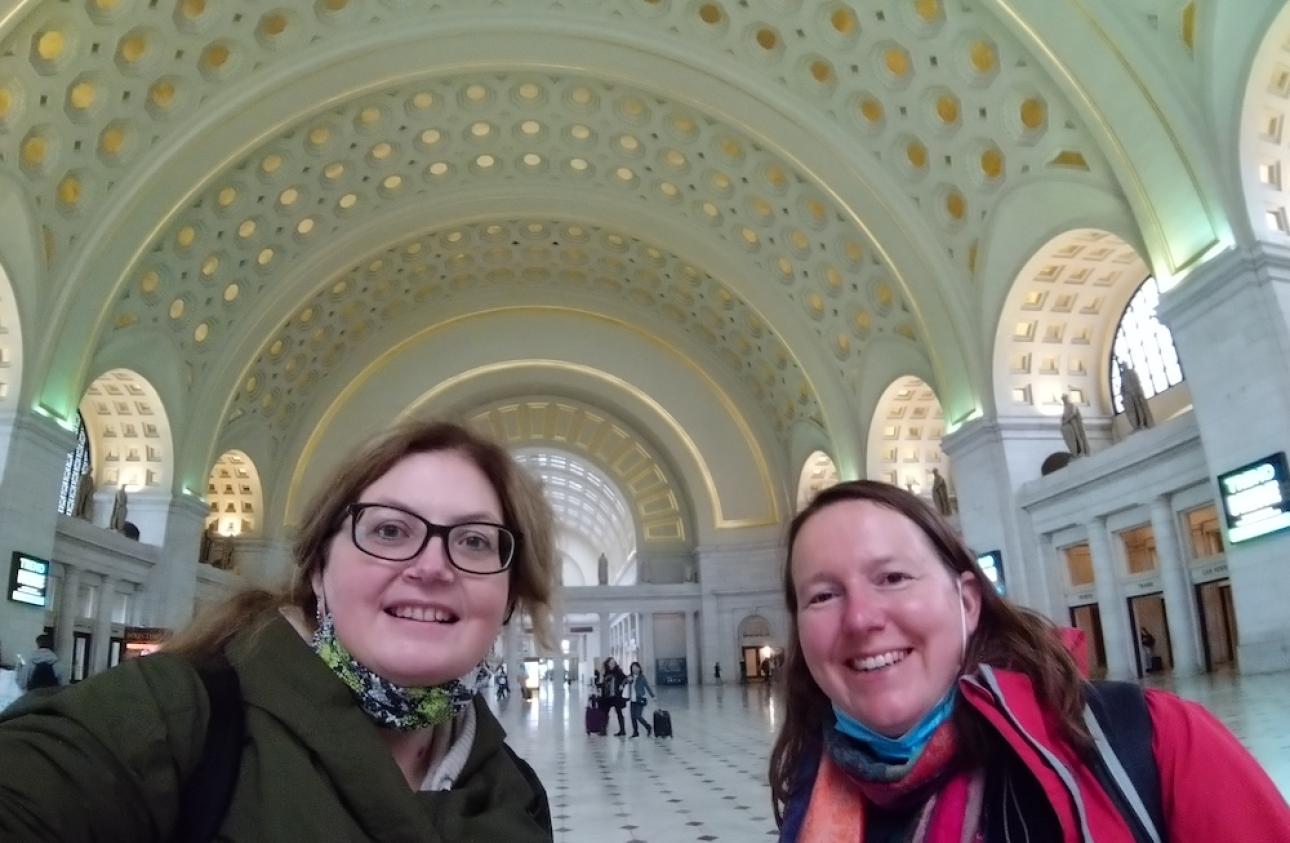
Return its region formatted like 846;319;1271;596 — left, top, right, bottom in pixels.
219;219;820;441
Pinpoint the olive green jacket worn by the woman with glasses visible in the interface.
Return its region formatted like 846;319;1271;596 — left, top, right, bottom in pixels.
0;617;552;843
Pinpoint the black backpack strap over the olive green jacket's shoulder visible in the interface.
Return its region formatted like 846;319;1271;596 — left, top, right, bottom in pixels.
170;658;246;843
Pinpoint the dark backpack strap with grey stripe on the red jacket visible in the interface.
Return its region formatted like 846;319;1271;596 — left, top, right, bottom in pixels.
1084;682;1169;843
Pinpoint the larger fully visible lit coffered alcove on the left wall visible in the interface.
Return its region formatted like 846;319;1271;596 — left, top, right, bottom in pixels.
80;369;174;496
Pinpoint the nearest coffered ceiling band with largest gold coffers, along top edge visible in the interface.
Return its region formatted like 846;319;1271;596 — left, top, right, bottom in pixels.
0;0;1100;286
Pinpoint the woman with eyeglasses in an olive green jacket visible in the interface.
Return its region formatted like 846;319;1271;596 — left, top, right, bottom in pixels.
0;422;555;842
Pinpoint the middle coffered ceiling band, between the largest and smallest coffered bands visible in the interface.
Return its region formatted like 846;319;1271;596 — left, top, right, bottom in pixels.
105;75;920;400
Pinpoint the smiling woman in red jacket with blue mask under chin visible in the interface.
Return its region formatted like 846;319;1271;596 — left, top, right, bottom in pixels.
770;480;1290;843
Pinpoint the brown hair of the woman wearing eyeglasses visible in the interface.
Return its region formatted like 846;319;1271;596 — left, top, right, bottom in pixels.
165;421;556;661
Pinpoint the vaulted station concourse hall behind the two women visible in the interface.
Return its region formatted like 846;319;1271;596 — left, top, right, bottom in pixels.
0;0;1290;843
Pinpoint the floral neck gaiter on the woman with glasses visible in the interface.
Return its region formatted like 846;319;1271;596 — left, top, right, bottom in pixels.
310;612;475;732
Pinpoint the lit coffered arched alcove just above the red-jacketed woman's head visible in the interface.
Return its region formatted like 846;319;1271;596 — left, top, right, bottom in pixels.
867;376;949;496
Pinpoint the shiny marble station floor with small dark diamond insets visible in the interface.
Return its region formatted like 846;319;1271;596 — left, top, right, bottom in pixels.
499;674;1290;843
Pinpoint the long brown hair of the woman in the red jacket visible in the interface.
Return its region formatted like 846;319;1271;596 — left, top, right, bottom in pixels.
770;480;1090;822
